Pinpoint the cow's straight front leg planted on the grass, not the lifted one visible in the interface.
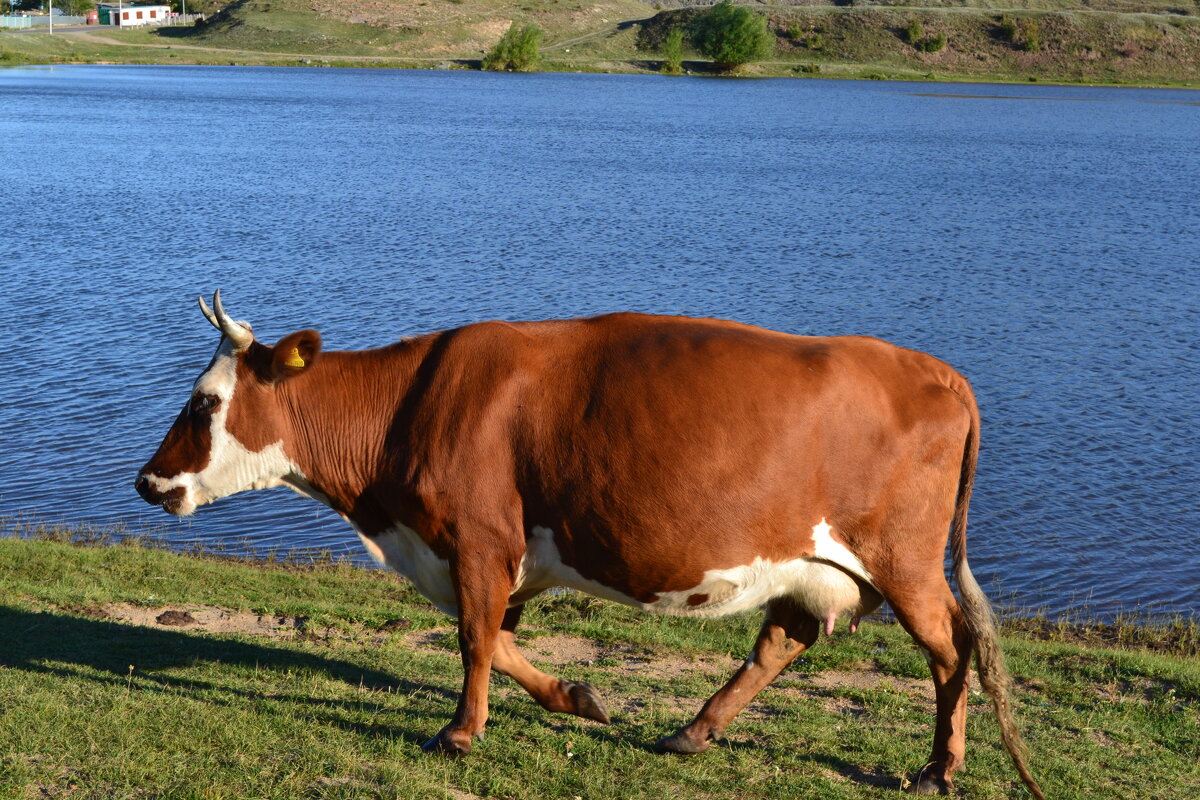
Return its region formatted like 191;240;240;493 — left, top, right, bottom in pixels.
422;554;512;756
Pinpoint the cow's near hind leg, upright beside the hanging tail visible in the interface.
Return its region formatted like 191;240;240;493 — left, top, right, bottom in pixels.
884;575;973;794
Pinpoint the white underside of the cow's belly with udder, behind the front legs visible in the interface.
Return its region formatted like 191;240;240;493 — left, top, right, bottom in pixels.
511;519;882;620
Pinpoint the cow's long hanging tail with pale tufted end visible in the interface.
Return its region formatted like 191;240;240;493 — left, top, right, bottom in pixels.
950;380;1044;800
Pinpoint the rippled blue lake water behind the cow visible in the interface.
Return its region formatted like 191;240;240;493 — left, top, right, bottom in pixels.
0;66;1200;616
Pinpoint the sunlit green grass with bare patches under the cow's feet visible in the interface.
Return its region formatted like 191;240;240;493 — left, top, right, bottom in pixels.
0;539;1200;799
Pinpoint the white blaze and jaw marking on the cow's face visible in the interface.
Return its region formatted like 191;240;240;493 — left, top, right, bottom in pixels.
146;338;304;516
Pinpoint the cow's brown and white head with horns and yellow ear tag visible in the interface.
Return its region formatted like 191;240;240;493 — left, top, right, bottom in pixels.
134;289;320;515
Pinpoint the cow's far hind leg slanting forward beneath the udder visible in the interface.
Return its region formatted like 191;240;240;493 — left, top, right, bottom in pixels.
654;600;821;753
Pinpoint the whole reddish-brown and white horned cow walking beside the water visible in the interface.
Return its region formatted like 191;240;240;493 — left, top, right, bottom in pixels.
137;293;1042;798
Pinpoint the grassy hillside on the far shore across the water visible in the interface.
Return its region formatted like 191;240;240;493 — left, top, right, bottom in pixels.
0;0;1200;86
